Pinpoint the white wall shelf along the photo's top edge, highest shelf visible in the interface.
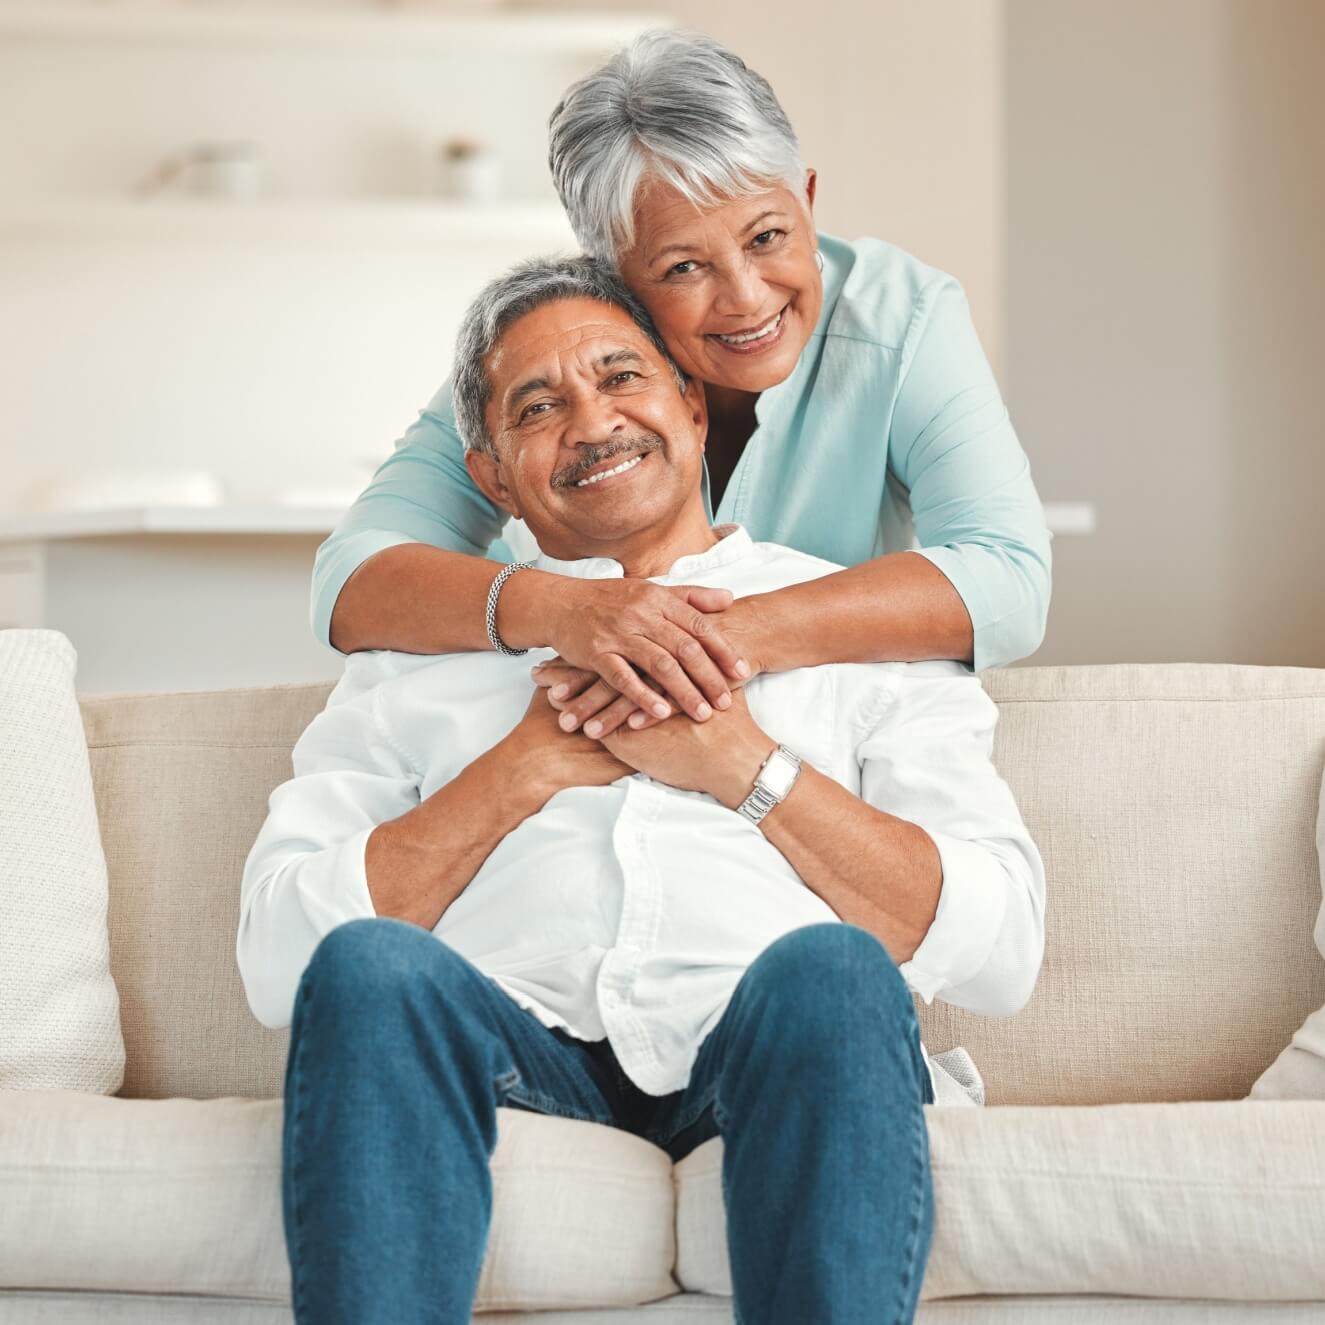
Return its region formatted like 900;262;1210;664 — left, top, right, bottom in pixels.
0;0;672;54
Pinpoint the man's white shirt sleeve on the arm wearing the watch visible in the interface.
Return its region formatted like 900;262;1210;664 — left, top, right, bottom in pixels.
857;664;1045;1016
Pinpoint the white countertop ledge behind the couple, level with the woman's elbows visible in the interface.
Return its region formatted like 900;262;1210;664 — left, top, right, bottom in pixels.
0;502;1094;543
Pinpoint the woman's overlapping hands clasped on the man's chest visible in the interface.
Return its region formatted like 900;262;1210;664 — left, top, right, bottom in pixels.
534;578;754;735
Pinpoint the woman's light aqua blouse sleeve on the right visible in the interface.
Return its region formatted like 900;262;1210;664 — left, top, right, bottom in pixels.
890;278;1052;672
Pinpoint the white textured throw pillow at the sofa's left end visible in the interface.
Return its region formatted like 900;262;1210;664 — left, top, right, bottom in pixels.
0;631;125;1094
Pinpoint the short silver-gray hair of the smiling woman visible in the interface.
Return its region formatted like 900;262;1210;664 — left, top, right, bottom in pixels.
547;29;806;265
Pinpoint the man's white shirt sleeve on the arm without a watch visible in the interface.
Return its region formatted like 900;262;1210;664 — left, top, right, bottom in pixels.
235;652;420;1030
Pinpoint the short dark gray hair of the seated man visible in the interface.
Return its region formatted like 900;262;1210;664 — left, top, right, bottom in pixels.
451;256;686;460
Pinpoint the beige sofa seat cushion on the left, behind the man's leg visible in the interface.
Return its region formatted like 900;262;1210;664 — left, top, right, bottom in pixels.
0;1090;677;1310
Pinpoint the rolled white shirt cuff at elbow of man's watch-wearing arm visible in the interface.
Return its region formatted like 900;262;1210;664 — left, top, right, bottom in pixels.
897;828;1007;1003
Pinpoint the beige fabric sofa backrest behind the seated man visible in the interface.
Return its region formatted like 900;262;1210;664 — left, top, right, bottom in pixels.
83;664;1325;1105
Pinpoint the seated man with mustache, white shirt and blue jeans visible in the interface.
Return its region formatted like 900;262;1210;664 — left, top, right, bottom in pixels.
236;258;1044;1325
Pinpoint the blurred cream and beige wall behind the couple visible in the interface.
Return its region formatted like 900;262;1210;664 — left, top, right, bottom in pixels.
0;0;1325;689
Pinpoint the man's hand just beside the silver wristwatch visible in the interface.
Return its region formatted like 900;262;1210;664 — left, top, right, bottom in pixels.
593;689;778;810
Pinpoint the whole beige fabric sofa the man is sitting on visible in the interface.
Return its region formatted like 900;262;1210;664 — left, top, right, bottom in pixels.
0;664;1325;1325
